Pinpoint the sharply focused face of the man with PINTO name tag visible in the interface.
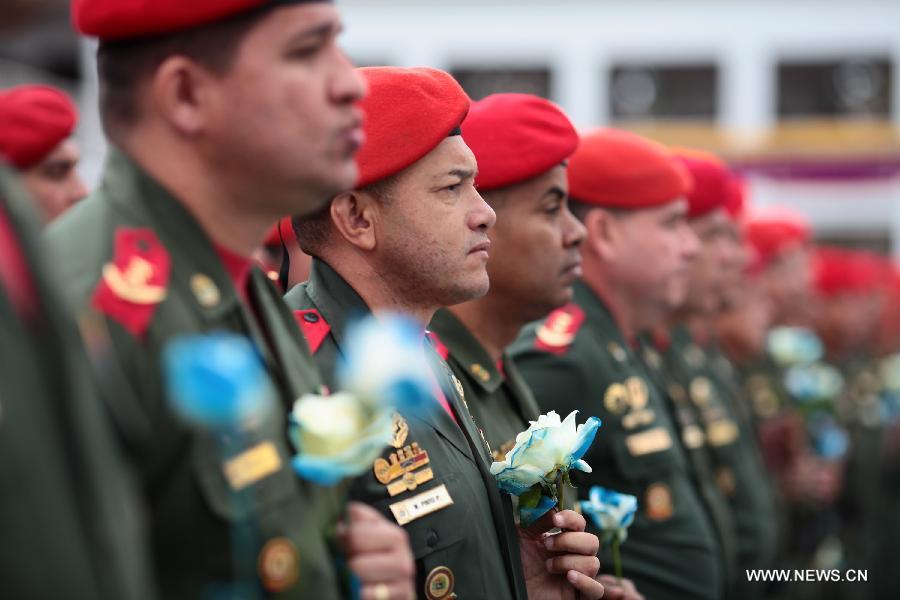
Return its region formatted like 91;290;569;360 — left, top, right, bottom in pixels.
375;135;496;306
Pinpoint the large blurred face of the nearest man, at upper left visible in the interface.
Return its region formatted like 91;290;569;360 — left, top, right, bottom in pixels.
208;3;365;214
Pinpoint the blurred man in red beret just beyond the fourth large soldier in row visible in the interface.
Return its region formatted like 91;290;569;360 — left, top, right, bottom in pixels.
652;150;776;598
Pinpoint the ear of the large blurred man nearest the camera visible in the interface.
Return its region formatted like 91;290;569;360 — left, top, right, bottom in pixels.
149;55;223;136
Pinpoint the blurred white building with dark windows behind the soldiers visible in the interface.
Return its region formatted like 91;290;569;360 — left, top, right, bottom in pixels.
0;0;900;256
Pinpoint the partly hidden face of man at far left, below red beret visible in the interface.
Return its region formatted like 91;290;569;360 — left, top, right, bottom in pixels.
22;140;88;223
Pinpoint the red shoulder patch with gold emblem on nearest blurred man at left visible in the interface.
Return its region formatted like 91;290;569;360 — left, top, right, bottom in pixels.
91;227;171;336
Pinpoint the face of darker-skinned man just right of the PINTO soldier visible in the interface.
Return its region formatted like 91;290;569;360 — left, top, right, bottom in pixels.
486;165;585;320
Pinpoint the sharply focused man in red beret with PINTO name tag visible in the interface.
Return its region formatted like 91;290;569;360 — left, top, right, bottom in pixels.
286;67;603;600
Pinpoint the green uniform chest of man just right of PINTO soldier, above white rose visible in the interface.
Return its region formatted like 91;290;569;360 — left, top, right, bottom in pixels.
429;308;540;461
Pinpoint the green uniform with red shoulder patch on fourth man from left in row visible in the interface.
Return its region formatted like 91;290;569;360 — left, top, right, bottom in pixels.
510;282;724;600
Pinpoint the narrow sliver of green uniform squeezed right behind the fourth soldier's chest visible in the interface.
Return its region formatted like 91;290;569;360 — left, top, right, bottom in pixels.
639;335;737;595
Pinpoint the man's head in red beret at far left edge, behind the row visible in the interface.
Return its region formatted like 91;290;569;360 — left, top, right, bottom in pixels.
0;85;87;223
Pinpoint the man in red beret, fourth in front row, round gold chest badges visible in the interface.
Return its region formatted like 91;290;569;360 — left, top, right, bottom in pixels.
511;129;724;599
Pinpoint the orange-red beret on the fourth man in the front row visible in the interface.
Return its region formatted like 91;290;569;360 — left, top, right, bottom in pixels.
569;129;692;209
